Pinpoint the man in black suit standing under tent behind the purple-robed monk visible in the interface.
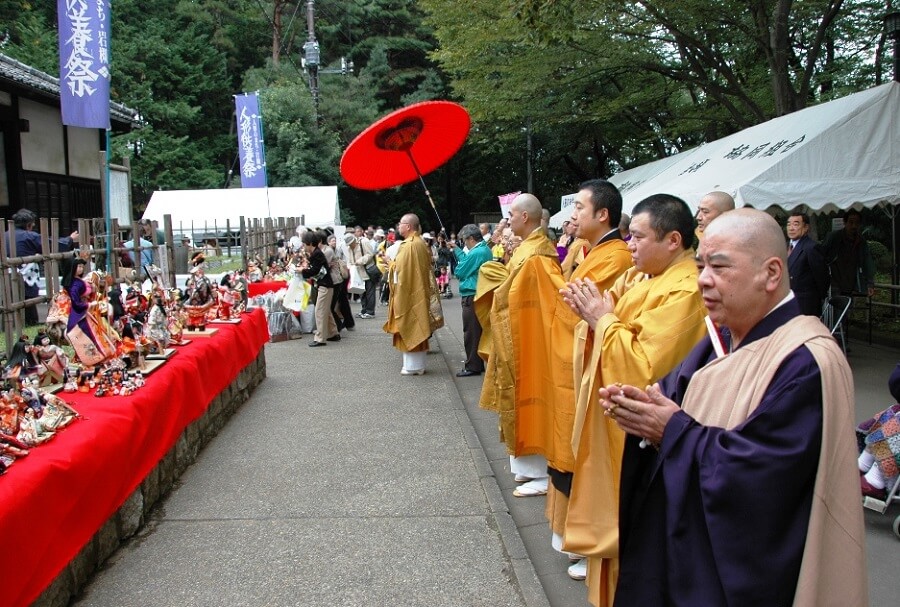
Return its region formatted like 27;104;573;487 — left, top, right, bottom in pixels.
786;211;829;316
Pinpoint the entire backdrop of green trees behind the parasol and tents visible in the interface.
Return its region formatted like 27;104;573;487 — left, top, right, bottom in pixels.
0;0;889;238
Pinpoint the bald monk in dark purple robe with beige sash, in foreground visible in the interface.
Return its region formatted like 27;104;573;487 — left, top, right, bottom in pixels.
600;209;869;607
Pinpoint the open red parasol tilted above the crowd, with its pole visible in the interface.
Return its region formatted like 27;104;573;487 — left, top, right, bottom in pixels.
341;101;471;233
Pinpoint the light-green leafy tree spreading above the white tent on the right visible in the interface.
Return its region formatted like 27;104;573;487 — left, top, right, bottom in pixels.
420;0;882;204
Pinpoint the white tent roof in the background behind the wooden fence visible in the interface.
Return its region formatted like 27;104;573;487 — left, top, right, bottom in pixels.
142;186;341;230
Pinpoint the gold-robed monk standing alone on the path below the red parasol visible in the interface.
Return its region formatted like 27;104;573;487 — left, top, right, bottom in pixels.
384;213;444;375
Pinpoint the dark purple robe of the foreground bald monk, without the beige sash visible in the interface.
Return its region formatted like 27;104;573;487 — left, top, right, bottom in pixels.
615;347;822;606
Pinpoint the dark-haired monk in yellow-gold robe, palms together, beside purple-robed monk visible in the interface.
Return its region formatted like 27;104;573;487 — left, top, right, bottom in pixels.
563;194;706;607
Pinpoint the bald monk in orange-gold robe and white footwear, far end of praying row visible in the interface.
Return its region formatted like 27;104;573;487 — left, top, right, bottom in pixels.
476;194;562;497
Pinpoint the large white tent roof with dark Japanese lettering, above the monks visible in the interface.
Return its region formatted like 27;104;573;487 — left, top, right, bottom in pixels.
614;82;900;213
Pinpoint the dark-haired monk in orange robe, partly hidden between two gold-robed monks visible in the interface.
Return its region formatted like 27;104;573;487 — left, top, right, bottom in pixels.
536;179;631;579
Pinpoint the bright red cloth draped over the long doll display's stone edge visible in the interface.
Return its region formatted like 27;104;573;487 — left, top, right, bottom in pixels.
0;309;269;606
